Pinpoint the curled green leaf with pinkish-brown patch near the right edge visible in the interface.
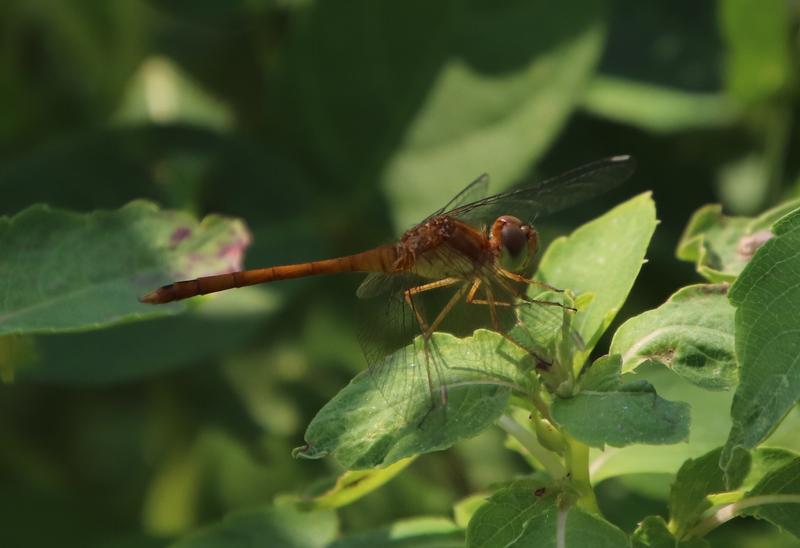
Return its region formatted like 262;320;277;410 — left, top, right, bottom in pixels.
676;200;800;283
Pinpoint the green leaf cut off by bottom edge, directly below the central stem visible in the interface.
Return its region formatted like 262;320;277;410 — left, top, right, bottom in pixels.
467;480;628;548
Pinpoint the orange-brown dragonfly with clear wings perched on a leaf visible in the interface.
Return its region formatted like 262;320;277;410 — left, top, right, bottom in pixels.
140;155;635;418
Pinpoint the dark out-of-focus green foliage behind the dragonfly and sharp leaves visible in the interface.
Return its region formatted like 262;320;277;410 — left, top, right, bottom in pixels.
0;0;800;547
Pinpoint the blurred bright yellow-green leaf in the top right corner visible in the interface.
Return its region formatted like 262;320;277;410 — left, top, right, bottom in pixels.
718;0;793;102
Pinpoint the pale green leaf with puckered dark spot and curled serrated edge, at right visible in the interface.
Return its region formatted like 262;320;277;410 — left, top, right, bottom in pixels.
610;284;736;390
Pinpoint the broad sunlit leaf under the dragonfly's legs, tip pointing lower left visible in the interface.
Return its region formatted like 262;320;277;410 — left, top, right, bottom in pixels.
295;330;529;469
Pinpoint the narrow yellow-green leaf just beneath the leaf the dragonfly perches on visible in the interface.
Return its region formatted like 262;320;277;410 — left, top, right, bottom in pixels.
298;457;414;510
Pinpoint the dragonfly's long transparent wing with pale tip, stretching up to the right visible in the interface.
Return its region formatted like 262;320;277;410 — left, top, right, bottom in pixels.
444;155;636;226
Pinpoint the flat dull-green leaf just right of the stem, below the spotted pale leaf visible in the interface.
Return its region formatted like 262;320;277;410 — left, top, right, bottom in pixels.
551;354;689;447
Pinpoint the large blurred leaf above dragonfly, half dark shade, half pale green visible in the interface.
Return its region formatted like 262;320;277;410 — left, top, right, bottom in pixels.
284;0;606;227
